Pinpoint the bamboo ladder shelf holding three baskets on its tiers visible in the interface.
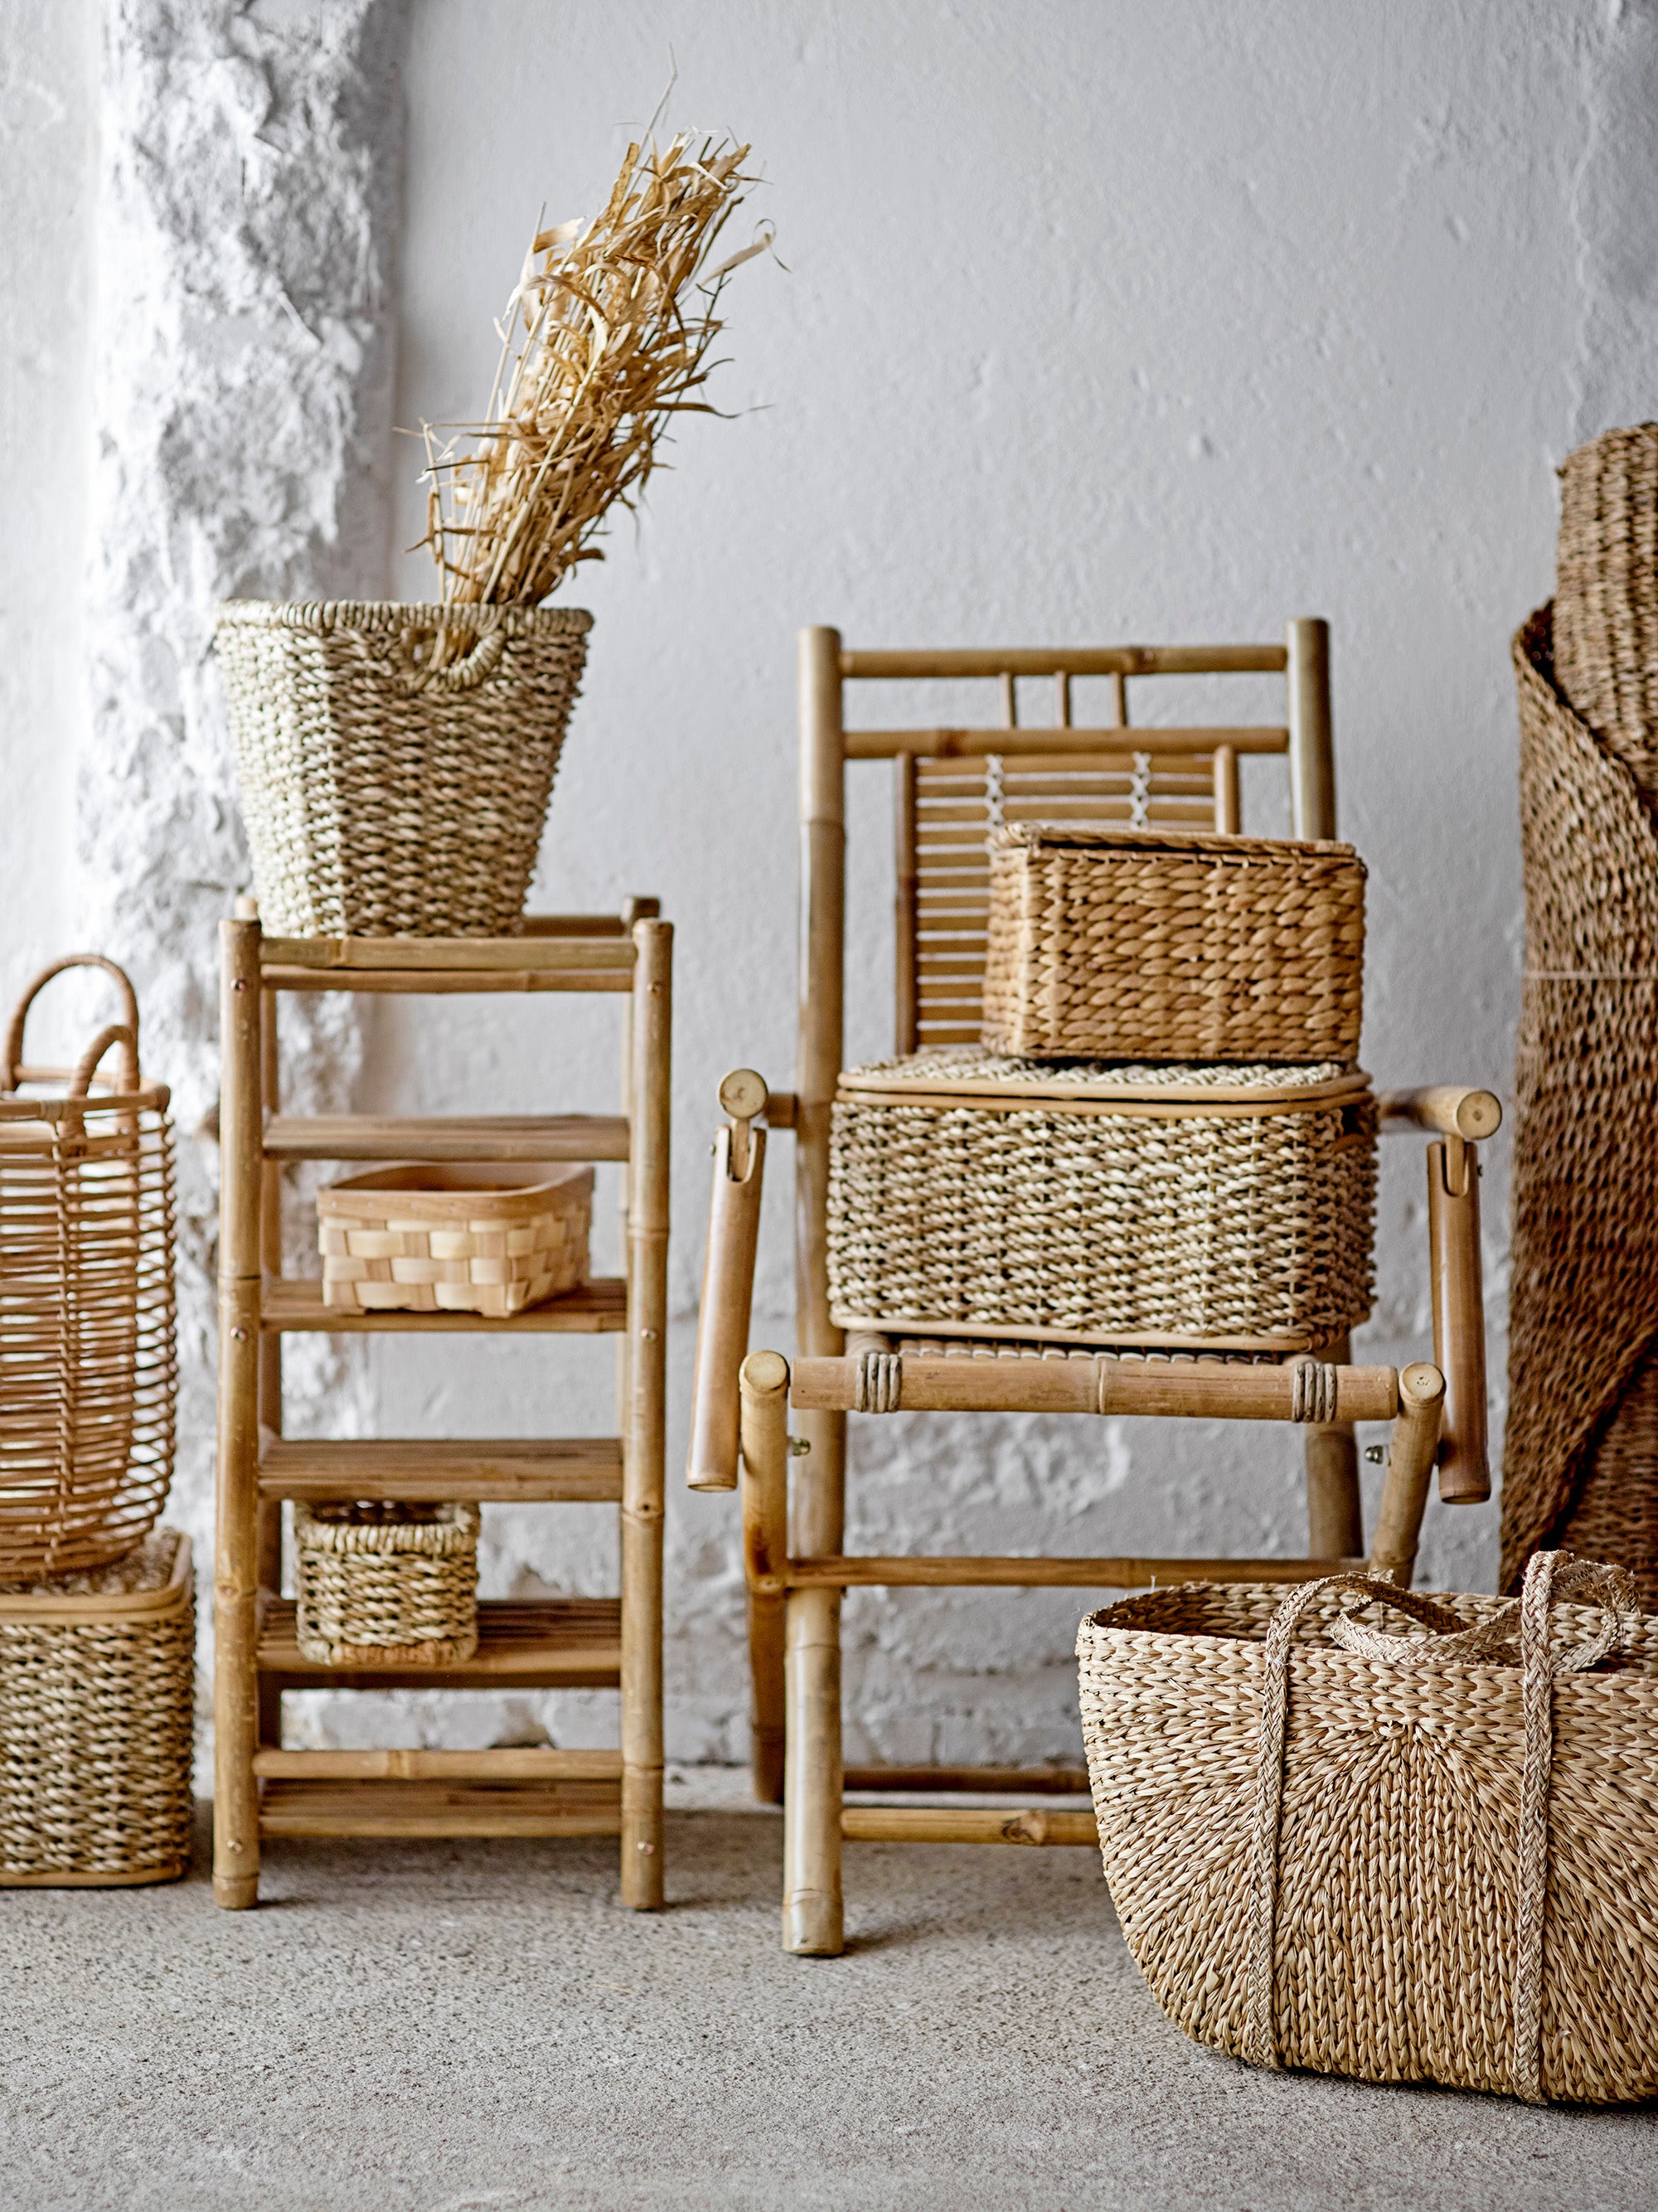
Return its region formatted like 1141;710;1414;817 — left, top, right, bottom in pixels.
212;898;674;1909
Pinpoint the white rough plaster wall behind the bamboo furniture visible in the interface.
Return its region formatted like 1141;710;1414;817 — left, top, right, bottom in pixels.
0;0;1658;1758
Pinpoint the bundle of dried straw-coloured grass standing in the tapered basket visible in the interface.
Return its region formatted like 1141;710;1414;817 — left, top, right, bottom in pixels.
422;133;772;606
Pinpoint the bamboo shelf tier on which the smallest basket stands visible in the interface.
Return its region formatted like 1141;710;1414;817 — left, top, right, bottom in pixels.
259;1597;621;1690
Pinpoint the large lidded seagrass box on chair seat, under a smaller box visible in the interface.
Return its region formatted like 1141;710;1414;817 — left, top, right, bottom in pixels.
829;1049;1377;1351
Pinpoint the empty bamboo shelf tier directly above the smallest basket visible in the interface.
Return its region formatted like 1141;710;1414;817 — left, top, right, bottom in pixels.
259;1436;621;1504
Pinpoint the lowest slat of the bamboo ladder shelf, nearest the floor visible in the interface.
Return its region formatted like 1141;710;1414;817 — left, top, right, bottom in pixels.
259;1781;621;1836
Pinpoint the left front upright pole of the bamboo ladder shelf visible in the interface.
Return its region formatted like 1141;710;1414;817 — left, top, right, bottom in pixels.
212;920;263;1911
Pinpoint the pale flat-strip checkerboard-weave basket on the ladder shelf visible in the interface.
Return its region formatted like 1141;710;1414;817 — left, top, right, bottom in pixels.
316;1166;593;1316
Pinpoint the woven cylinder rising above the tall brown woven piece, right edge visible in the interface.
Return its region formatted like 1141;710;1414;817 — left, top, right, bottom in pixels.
1554;423;1658;798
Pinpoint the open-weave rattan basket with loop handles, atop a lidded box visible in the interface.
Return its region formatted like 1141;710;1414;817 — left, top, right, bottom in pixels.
0;953;179;1582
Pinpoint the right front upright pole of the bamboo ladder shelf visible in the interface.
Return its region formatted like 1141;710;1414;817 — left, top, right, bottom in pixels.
621;920;674;1911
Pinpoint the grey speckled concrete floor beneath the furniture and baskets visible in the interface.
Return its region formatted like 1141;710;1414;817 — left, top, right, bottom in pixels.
0;1809;1658;2212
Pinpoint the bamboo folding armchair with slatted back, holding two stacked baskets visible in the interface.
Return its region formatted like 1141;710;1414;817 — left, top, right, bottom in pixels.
687;622;1501;1956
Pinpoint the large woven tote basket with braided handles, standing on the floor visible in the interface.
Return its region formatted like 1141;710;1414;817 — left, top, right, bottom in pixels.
1077;1553;1658;2103
